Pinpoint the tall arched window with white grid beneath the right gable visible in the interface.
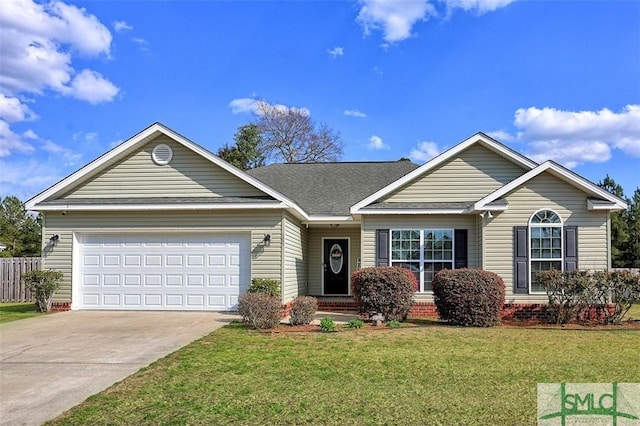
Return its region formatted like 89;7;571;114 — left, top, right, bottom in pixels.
529;210;564;293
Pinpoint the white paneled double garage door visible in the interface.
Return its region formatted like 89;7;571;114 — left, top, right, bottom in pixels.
74;235;250;311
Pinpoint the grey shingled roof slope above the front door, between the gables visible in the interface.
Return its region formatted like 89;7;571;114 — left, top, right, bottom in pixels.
247;161;418;216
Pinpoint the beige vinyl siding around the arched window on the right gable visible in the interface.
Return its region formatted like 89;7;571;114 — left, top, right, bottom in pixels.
484;173;609;302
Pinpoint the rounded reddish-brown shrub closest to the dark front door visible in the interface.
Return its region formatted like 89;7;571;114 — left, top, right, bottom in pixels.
351;266;418;321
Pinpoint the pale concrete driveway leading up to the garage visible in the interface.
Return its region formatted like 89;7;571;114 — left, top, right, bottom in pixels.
0;311;239;425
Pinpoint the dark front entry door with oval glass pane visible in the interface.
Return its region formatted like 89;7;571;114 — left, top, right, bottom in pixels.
323;238;349;294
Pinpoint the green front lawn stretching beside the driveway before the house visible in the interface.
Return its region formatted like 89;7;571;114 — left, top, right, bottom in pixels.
50;322;640;425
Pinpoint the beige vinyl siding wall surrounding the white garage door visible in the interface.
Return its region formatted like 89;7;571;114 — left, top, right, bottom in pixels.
42;211;282;301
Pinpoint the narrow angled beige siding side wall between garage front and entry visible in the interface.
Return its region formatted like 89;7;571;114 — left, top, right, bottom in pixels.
282;213;309;303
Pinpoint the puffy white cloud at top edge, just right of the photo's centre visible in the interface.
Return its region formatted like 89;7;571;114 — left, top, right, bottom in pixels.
356;0;436;42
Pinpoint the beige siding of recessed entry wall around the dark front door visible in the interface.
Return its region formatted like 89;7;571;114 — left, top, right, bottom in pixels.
308;226;360;296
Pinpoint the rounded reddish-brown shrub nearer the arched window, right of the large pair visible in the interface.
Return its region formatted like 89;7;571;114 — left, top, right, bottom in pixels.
433;269;505;327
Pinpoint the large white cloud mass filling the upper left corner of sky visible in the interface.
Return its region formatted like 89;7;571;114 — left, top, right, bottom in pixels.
0;0;120;156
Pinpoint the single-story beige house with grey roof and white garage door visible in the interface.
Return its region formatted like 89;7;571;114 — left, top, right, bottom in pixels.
26;123;626;313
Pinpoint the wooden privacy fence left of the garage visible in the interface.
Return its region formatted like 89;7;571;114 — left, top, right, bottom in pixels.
0;257;41;303
